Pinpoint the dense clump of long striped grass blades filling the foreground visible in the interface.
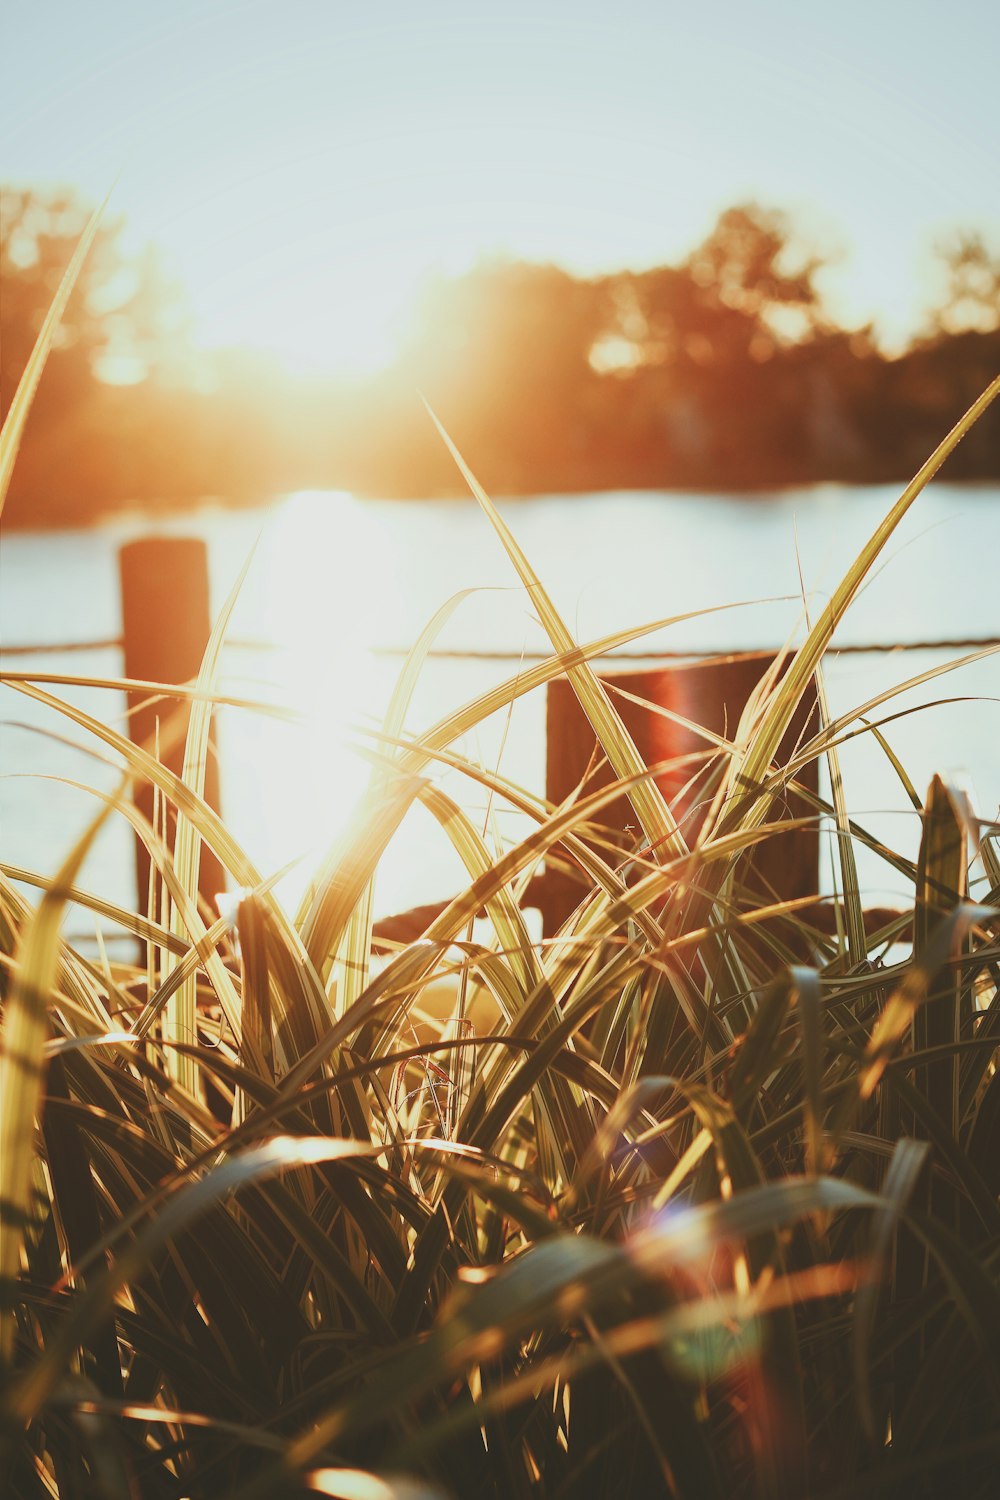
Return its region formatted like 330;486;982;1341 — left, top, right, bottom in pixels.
0;240;1000;1500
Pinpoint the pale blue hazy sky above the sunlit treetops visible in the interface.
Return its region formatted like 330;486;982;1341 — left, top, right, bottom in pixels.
0;0;1000;372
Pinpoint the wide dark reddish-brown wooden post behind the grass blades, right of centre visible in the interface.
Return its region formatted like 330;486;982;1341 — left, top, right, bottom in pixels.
531;654;819;938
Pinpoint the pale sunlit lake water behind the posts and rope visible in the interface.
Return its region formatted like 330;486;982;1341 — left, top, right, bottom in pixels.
0;483;1000;939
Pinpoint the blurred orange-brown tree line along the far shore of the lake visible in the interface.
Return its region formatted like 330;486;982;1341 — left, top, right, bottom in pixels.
0;192;1000;527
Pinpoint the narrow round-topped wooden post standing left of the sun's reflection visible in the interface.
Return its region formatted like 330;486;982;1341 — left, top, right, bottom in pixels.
118;537;225;911
